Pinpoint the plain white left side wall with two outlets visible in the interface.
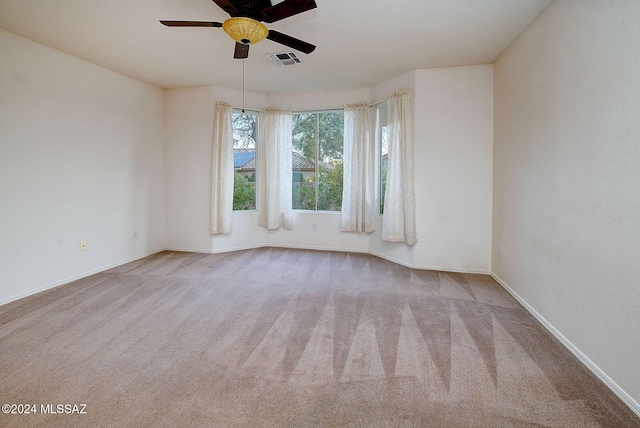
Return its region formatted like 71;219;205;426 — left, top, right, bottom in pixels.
0;31;164;304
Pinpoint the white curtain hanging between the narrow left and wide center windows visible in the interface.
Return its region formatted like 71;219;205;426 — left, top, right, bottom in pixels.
258;109;293;230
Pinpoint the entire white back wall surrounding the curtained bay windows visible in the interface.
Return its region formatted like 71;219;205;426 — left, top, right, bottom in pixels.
167;66;493;273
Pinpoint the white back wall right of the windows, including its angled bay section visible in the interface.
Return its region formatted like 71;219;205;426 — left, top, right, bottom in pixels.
370;65;493;273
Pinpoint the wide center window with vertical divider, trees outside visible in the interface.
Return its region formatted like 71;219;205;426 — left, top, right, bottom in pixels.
292;110;344;211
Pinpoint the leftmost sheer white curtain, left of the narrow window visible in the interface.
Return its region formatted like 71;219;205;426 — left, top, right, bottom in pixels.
211;102;233;235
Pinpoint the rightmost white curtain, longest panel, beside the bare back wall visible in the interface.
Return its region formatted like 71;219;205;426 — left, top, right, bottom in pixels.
382;91;418;245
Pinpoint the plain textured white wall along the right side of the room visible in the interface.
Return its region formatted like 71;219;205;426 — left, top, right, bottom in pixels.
492;0;640;413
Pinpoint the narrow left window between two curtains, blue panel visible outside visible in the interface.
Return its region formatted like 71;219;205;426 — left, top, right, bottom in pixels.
231;111;258;211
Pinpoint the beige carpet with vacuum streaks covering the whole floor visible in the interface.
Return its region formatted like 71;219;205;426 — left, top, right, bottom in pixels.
0;248;640;427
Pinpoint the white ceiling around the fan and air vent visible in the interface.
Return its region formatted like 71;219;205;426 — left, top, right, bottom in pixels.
0;0;553;93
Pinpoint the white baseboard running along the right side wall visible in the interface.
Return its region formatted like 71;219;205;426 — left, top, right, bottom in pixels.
491;272;640;416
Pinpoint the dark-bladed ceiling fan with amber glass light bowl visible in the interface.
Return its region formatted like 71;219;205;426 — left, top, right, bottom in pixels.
160;0;317;59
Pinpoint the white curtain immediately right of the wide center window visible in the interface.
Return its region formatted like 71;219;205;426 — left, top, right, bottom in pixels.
341;104;375;233
